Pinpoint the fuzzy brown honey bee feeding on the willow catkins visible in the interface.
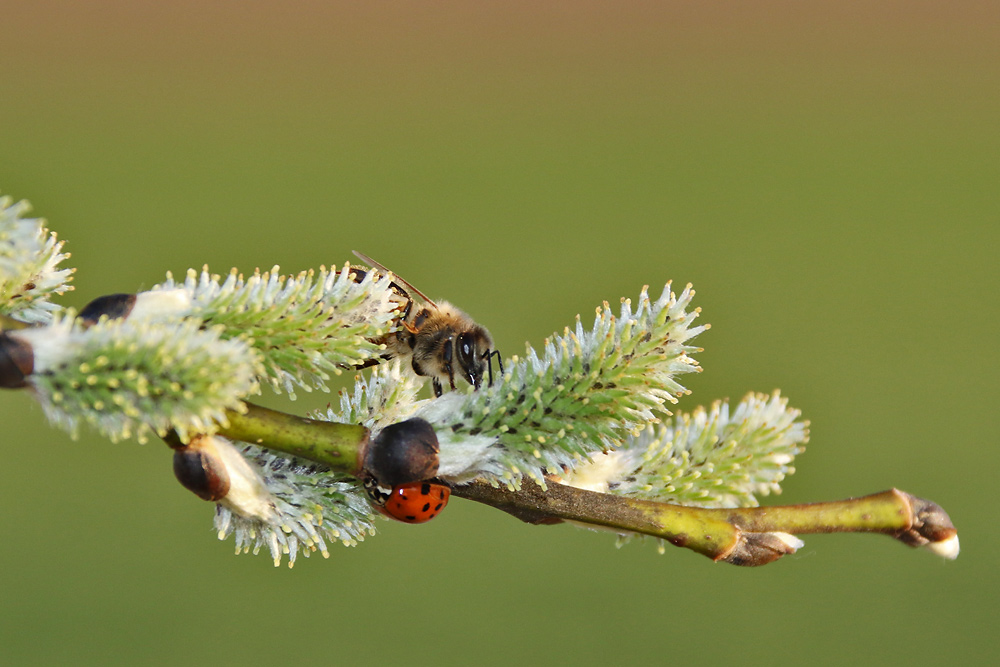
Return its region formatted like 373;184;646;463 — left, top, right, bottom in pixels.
352;250;503;396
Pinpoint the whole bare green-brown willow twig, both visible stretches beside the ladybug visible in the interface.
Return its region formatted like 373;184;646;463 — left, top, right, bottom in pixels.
220;404;956;565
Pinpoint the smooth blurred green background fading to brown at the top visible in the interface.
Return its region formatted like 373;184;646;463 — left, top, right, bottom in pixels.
0;1;1000;665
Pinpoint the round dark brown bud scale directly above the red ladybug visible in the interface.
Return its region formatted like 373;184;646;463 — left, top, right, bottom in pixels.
365;418;440;486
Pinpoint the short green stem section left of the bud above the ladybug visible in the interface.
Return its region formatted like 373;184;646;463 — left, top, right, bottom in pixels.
219;403;368;475
